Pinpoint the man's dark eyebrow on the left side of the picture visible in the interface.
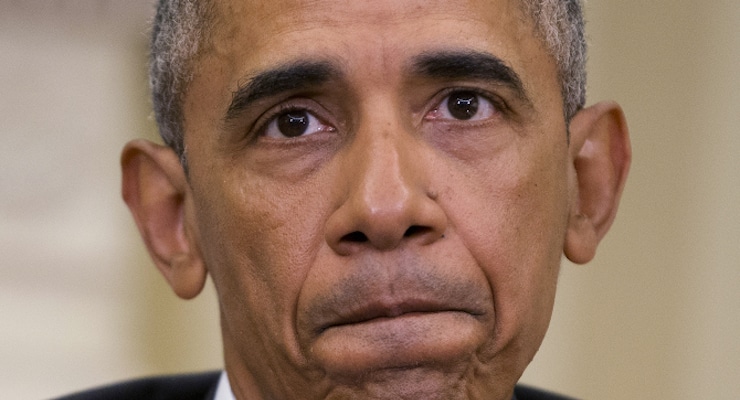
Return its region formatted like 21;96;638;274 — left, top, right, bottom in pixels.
225;61;340;121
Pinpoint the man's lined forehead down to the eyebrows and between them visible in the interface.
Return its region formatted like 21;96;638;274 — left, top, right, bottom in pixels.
185;0;560;124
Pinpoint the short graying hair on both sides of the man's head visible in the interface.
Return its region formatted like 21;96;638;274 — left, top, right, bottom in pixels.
149;0;586;158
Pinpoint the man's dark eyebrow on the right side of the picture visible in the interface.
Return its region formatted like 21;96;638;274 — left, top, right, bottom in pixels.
411;51;532;105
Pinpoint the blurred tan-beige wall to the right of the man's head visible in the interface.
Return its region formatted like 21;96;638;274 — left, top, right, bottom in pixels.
526;0;740;399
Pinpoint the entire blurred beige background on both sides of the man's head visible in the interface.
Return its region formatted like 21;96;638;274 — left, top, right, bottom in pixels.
0;0;740;399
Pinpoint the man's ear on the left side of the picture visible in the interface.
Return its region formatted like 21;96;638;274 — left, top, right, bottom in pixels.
121;140;207;299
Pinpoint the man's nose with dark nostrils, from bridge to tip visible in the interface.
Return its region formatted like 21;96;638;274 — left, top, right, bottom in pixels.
326;122;447;255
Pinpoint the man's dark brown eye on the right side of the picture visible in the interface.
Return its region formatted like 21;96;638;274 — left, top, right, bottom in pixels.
427;90;497;121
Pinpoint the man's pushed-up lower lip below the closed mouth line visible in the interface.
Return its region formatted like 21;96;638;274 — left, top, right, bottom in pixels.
311;311;485;375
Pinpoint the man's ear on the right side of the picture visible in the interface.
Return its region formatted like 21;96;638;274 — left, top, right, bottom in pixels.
564;102;632;264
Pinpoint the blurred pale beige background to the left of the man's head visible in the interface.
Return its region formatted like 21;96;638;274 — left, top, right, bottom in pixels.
0;0;221;399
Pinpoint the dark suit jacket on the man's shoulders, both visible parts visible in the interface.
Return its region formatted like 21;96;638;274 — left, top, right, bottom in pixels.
57;371;569;400
